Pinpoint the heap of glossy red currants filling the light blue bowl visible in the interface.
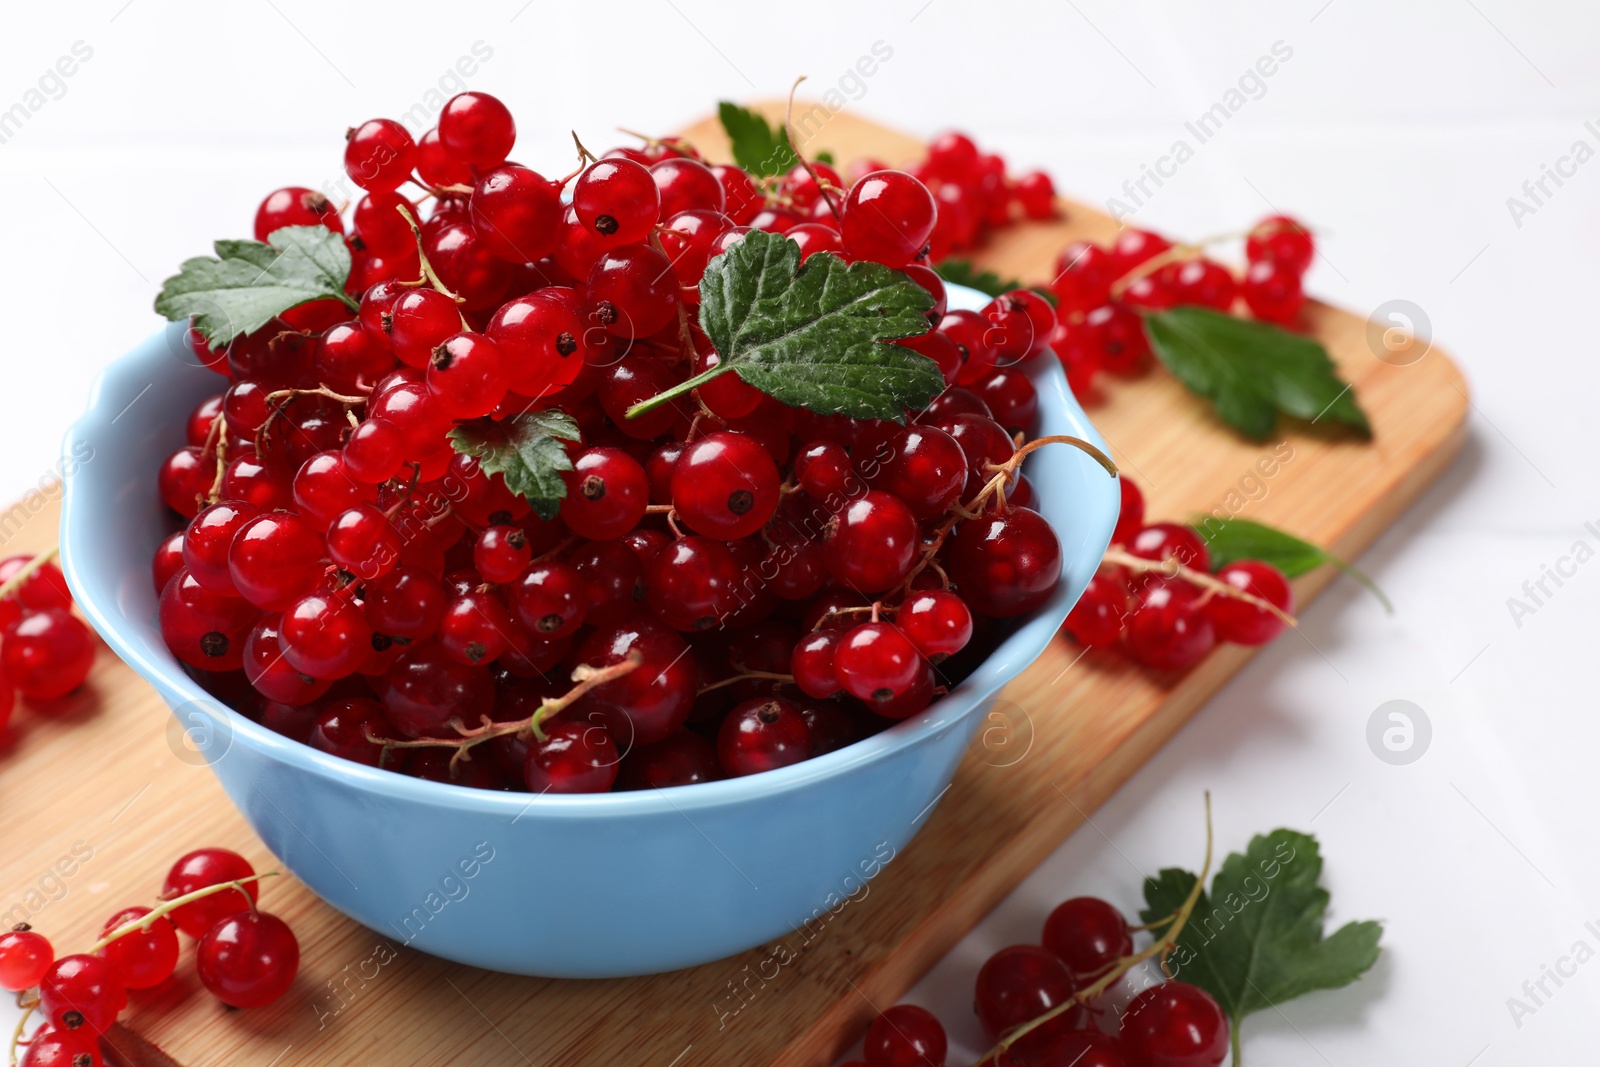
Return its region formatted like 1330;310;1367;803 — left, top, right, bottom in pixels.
154;93;1061;792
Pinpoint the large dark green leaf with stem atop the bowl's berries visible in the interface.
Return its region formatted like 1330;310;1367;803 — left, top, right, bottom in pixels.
629;230;944;422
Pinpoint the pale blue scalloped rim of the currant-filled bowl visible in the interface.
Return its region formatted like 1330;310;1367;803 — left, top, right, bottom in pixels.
61;285;1118;822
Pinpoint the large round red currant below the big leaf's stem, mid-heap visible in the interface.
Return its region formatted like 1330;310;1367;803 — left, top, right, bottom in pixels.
672;430;779;541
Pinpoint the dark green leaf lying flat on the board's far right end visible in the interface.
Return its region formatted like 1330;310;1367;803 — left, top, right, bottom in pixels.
1144;307;1373;442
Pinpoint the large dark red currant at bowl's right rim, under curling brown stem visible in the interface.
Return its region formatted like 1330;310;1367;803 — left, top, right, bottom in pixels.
946;507;1061;619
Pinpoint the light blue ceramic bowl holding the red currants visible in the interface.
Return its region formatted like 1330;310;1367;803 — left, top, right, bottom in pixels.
61;283;1118;977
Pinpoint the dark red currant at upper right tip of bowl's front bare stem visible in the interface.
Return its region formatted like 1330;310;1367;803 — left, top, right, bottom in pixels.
574;614;699;749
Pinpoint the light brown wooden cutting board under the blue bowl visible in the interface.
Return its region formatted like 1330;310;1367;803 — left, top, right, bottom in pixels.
0;107;1467;1067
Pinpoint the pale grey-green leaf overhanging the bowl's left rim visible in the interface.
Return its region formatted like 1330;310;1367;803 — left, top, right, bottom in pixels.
155;226;357;347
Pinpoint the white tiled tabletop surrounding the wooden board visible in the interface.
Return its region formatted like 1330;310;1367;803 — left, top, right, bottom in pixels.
0;0;1600;1067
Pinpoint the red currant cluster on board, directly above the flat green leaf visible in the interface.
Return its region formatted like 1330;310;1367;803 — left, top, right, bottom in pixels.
1050;214;1315;397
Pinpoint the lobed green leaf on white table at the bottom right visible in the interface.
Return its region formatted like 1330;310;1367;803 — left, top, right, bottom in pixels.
1141;830;1382;1062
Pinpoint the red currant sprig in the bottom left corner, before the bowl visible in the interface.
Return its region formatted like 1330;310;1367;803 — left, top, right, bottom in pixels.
0;848;299;1067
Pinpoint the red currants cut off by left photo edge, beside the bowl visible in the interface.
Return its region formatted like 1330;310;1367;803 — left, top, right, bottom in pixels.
0;555;94;729
